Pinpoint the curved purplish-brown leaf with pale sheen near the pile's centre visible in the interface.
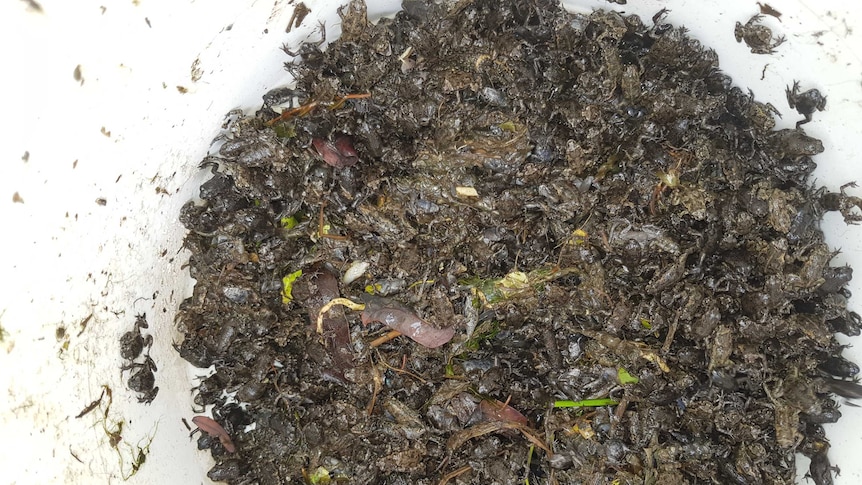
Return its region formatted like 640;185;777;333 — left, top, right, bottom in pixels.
362;294;455;349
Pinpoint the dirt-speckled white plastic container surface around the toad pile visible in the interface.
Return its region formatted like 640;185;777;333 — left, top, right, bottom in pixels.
0;0;862;484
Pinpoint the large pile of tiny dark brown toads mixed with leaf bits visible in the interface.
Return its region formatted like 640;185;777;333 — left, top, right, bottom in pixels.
177;0;862;485
